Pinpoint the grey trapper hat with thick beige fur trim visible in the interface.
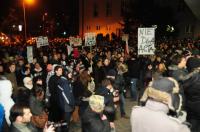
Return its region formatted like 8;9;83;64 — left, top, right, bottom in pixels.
140;77;182;113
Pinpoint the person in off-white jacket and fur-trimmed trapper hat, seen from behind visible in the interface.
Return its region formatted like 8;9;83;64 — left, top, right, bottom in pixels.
130;77;190;132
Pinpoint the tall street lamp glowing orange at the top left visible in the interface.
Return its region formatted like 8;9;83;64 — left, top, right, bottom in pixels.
22;0;34;42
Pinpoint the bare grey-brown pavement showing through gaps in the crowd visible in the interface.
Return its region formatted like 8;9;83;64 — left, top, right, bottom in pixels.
71;98;136;132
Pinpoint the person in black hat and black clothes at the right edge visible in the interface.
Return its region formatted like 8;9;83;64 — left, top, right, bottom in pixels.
183;57;200;132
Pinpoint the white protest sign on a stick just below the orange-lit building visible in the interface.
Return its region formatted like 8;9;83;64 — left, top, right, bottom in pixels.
85;33;96;46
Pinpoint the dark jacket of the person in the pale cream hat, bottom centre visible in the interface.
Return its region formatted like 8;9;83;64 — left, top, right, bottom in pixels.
82;107;111;132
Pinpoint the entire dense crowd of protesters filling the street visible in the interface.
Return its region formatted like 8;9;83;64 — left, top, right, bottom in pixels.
0;35;200;132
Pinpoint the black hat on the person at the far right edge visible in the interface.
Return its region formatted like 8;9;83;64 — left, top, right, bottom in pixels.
186;57;200;72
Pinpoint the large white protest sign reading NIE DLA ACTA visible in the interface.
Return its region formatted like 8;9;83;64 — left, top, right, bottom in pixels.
138;28;155;55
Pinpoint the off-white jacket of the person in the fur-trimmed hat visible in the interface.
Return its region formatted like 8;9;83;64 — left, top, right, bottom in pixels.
130;100;190;132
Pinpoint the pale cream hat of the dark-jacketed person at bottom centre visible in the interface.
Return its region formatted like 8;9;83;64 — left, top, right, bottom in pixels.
89;95;105;113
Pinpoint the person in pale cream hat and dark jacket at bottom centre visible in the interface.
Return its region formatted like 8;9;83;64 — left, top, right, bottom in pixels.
81;95;111;132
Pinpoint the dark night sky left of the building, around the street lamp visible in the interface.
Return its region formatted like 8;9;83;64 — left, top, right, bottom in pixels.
0;0;78;35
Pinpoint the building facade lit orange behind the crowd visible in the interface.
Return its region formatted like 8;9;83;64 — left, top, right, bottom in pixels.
79;0;125;36
